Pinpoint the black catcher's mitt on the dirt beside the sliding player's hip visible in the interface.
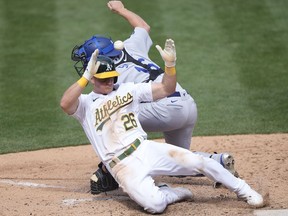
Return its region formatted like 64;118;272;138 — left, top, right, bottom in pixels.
90;163;119;195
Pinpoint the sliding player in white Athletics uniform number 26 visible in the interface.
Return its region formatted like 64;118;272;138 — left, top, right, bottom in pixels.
60;36;263;213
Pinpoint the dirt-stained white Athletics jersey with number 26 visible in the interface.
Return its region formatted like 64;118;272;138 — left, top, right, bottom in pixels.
73;83;152;162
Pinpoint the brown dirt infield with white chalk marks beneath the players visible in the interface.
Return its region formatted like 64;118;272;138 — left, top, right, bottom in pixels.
0;134;288;216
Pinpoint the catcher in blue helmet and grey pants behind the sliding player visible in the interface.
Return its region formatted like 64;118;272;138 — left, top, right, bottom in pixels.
72;1;237;194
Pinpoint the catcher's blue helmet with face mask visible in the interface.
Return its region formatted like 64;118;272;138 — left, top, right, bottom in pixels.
71;35;121;77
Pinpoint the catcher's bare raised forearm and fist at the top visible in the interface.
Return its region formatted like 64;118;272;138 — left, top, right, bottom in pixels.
107;1;150;32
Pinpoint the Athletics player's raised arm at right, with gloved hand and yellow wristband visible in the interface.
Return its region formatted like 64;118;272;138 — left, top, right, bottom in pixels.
152;39;177;100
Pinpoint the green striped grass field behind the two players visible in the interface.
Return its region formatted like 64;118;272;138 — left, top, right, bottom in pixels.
0;0;288;154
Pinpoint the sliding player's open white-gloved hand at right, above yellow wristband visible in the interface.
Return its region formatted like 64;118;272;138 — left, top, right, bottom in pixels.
156;39;177;67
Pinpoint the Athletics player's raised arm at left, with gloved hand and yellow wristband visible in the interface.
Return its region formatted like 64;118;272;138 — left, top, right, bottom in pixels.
60;49;100;115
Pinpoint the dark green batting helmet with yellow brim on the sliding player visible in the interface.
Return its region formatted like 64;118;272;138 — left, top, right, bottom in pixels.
94;55;120;83
